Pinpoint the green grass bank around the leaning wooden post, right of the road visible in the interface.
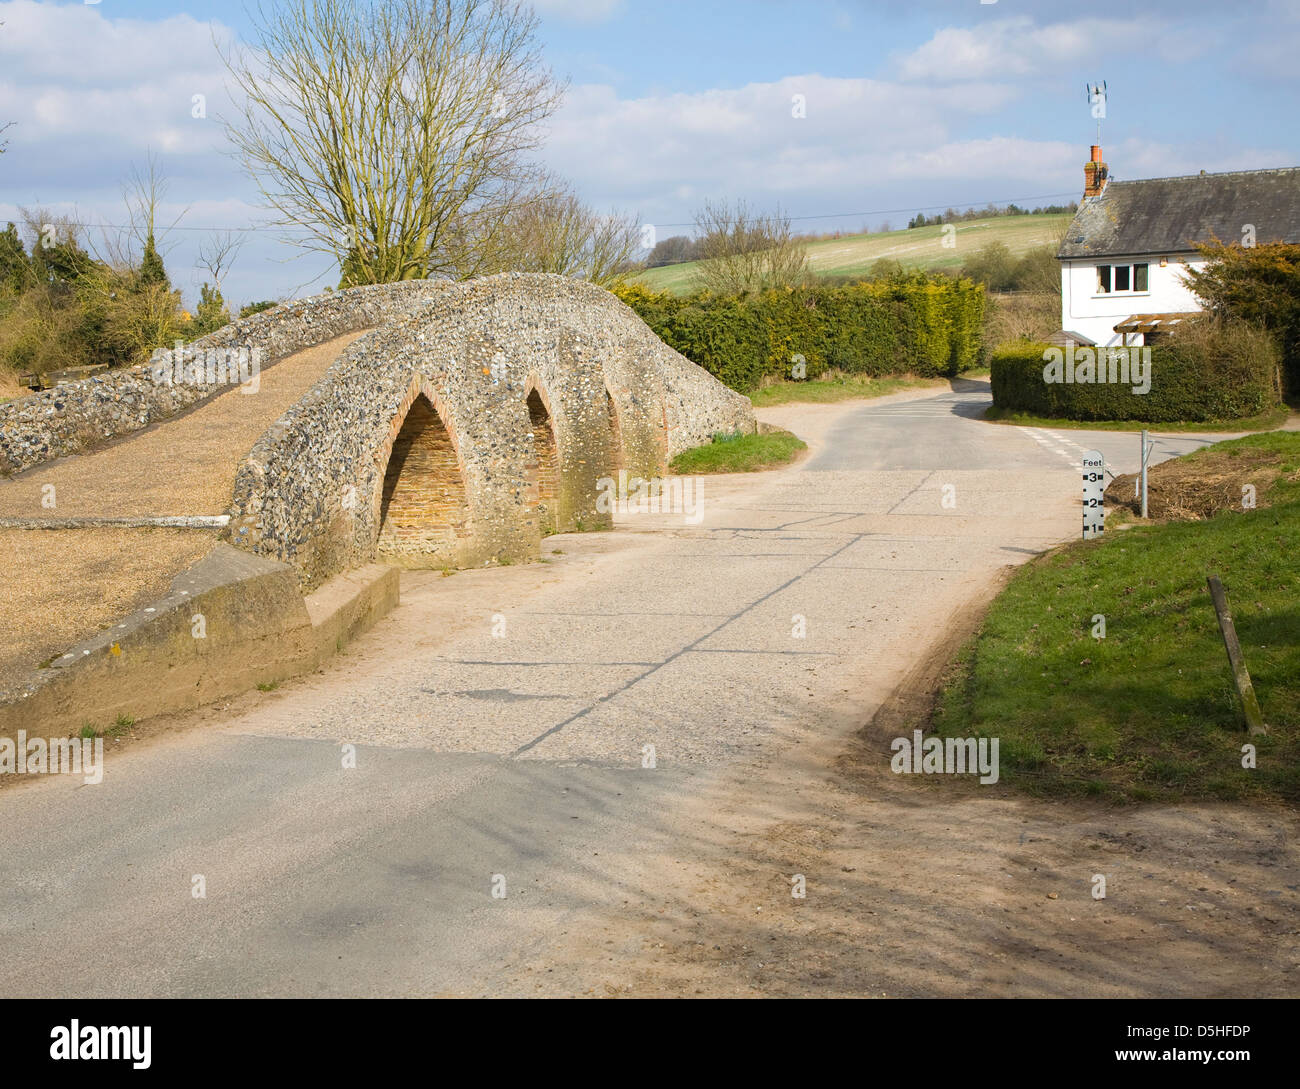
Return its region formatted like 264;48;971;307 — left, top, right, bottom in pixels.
932;435;1300;804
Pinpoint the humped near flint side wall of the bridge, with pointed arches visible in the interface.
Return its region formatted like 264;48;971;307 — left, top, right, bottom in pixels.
228;273;755;589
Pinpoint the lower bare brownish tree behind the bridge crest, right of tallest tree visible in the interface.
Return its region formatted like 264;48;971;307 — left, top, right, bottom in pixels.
484;177;641;287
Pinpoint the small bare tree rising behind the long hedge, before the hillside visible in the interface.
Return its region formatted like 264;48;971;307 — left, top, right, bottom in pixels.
696;201;807;295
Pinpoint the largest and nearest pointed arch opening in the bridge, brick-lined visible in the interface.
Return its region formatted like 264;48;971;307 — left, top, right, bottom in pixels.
376;394;469;564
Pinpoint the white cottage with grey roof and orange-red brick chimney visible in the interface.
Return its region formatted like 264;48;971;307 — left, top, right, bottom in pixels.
1052;146;1300;346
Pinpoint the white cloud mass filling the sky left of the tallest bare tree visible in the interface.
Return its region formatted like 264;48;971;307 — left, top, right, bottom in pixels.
0;0;280;298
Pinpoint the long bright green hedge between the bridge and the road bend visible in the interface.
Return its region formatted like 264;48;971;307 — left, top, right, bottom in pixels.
614;273;984;391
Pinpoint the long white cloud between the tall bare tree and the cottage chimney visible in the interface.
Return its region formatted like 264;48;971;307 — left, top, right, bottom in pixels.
546;75;1024;211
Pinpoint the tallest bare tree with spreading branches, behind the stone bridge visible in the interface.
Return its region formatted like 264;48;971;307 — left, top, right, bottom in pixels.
224;0;563;283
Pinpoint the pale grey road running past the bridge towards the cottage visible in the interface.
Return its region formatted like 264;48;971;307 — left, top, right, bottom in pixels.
0;383;1258;997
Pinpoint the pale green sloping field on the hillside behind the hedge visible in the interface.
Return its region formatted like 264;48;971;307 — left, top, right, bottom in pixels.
633;216;1070;295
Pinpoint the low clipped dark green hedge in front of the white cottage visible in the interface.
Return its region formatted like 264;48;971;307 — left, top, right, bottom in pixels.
991;326;1282;424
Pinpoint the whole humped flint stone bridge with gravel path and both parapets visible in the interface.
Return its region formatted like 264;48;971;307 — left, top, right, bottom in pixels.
0;274;755;733
